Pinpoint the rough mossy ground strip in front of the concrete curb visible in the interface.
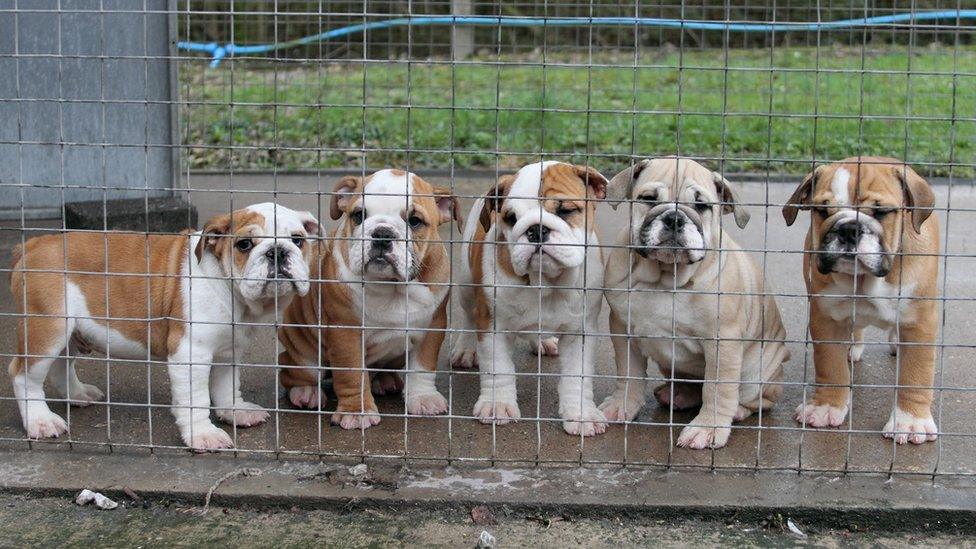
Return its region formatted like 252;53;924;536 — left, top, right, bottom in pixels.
7;496;974;547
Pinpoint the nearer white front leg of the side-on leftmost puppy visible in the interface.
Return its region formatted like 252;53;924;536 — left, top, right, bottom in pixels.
169;346;234;452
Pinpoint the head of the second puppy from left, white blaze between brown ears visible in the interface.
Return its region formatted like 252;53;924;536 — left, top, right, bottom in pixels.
332;169;458;282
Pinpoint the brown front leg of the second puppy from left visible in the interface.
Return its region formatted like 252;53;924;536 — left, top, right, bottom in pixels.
328;328;380;429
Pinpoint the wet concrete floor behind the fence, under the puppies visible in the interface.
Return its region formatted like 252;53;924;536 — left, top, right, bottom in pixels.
0;175;976;478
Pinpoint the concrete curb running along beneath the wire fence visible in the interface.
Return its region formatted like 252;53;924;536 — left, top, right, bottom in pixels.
0;451;976;532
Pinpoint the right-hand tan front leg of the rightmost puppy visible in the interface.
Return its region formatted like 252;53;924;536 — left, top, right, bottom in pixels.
884;318;939;444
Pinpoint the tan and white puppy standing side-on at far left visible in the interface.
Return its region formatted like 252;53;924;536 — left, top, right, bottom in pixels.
10;203;320;450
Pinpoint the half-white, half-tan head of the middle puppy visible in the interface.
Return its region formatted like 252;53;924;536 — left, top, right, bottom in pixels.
482;162;607;278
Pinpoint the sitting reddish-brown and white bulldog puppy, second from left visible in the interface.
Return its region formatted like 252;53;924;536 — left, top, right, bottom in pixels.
278;170;458;429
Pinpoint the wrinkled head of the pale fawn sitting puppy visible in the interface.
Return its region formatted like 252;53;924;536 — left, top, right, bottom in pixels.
609;157;749;265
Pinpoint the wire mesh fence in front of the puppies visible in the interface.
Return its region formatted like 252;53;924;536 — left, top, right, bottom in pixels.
0;0;976;475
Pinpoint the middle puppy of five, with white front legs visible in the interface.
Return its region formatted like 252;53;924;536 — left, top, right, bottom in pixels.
452;162;607;436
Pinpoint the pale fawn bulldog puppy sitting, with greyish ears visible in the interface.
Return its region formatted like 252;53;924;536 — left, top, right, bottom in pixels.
600;157;789;449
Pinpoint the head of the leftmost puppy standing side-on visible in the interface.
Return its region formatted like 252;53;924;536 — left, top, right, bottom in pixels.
197;202;322;303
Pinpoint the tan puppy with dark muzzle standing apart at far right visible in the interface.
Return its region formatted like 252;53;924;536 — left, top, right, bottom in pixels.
783;157;939;444
